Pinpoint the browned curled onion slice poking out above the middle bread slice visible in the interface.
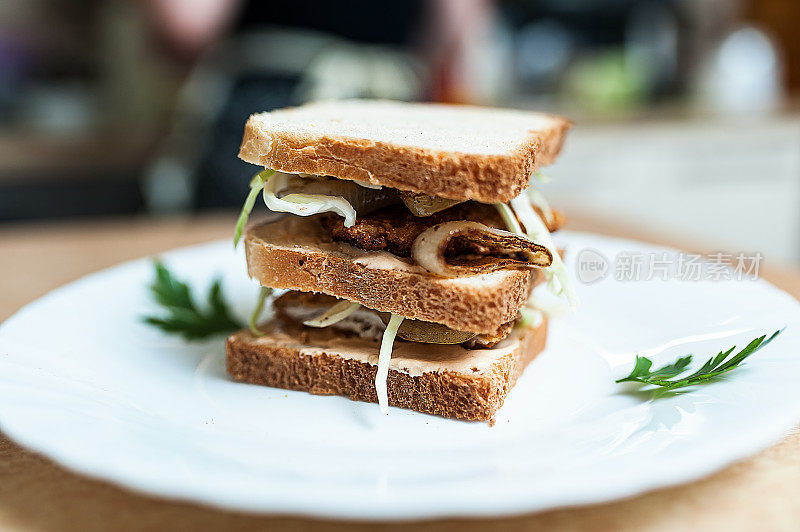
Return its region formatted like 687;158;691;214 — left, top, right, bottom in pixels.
411;221;553;277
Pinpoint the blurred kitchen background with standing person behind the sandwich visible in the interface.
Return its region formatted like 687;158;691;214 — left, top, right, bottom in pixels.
0;0;800;264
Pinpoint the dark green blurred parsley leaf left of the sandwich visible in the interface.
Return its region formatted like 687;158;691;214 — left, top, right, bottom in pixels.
143;260;242;340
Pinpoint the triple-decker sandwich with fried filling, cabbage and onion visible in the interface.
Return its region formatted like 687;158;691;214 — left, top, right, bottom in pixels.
226;100;576;420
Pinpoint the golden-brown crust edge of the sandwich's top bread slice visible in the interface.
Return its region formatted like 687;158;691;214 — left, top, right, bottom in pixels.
239;101;570;203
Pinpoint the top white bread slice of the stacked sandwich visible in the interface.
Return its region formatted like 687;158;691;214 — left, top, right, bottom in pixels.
239;100;570;203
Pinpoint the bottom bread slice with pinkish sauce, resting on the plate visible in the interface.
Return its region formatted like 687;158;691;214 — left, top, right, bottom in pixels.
226;320;547;421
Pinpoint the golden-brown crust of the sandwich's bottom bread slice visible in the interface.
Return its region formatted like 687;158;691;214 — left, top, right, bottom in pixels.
226;323;547;421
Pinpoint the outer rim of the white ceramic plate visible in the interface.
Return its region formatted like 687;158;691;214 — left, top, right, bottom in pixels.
0;231;800;522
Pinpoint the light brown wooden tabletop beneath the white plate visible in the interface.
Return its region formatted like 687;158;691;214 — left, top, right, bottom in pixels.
0;213;800;531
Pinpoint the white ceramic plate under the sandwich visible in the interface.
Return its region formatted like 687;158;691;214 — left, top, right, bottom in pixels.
0;233;800;519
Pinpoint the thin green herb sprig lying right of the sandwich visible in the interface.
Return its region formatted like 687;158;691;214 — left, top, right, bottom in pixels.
616;329;783;390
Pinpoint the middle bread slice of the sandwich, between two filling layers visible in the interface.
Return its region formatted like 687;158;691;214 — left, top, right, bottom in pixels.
245;216;538;334
